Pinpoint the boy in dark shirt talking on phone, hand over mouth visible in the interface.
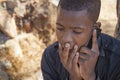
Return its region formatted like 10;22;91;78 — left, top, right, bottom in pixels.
41;0;120;80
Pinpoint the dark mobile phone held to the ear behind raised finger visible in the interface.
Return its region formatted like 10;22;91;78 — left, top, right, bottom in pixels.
86;26;101;49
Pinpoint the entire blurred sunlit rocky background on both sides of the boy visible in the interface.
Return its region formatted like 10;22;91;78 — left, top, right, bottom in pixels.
0;0;117;80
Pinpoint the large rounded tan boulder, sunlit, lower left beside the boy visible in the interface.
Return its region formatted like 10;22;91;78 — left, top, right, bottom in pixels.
2;33;45;80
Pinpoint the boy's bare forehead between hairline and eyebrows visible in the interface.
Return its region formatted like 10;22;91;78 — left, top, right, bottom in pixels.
57;8;93;26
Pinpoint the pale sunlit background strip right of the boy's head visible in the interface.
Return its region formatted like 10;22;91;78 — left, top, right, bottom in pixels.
98;0;117;36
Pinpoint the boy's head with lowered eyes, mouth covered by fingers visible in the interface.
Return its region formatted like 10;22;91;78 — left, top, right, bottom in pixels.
56;0;101;48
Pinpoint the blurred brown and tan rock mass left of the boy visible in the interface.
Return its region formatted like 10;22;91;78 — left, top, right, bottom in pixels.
0;0;55;80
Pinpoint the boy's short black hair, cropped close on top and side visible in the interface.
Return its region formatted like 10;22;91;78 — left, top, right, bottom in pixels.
58;0;101;22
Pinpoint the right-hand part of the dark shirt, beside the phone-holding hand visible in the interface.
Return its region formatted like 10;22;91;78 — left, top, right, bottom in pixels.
97;34;120;80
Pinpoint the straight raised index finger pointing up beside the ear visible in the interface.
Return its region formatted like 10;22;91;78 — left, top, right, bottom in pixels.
91;29;98;51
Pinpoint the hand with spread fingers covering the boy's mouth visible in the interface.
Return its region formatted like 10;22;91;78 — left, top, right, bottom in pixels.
59;43;82;80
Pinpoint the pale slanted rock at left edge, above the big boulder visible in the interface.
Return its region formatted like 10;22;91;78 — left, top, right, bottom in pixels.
0;10;17;38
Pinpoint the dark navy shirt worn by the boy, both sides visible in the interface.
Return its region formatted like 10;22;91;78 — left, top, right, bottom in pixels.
41;33;120;80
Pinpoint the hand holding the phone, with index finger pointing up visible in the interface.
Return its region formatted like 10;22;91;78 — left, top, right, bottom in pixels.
79;30;99;80
